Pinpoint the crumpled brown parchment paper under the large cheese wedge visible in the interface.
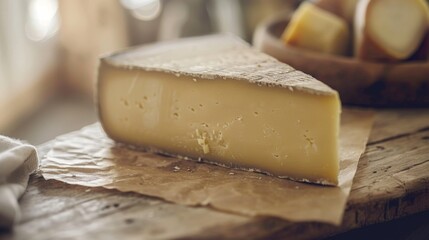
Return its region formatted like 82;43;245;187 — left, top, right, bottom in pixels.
41;109;373;225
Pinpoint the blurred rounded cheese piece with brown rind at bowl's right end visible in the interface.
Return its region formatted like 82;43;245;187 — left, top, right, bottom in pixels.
354;0;429;61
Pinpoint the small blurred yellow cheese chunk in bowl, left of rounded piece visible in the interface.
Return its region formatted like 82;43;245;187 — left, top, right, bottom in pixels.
282;2;349;55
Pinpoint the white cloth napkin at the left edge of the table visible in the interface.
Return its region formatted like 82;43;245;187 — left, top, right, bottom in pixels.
0;136;39;228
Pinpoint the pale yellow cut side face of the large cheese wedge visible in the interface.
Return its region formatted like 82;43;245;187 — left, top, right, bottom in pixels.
98;62;340;185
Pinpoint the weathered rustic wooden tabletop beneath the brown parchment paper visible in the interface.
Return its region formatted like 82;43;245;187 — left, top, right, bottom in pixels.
0;109;429;239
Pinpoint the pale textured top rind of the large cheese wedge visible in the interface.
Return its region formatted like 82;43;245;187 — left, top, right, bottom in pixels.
101;35;338;95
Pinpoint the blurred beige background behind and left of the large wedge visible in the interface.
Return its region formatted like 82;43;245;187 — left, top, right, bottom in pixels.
0;0;298;145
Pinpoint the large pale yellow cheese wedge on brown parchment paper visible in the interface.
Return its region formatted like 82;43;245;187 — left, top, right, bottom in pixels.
98;36;341;185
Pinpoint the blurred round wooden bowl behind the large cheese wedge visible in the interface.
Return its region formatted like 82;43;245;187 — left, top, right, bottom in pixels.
253;17;429;107
